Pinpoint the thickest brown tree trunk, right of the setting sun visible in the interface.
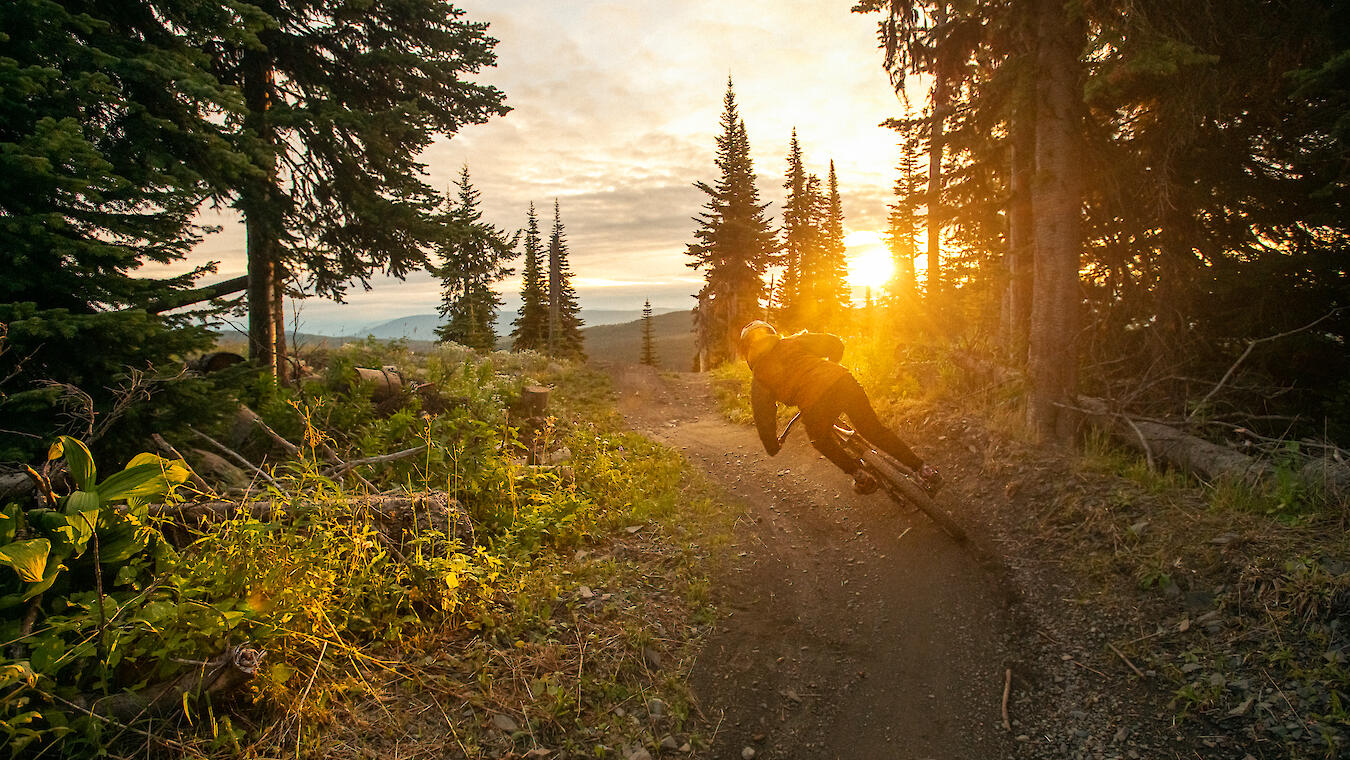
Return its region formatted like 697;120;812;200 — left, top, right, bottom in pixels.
1027;0;1084;440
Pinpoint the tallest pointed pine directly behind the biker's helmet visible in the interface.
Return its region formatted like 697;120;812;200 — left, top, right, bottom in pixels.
687;78;776;367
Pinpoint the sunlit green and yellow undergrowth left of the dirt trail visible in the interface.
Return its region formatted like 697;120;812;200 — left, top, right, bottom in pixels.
0;342;725;757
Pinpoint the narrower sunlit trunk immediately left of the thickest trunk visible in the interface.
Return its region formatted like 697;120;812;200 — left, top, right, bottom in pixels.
1003;77;1035;364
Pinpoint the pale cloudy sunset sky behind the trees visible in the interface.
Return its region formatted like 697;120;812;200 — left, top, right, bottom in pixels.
168;0;903;333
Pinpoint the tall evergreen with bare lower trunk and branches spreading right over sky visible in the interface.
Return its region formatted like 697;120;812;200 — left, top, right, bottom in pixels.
208;0;508;374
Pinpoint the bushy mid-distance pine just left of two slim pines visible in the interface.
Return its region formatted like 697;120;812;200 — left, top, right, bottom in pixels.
433;166;516;351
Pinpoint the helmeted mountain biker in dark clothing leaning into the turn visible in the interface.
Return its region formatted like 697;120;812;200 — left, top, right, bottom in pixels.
738;320;942;495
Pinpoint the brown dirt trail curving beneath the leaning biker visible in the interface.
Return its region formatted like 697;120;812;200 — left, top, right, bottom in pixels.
613;366;1014;760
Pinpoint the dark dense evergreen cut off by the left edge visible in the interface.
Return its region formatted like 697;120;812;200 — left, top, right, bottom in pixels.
0;0;243;459
